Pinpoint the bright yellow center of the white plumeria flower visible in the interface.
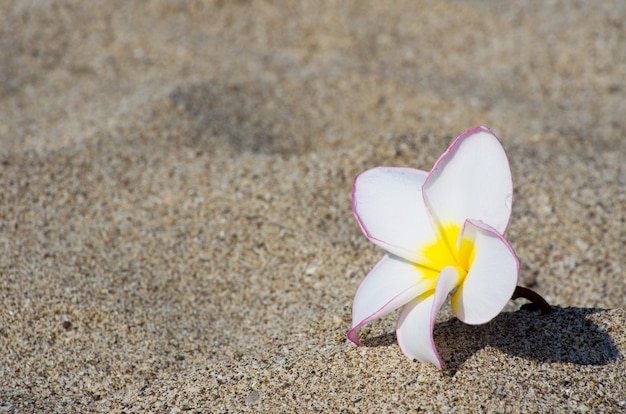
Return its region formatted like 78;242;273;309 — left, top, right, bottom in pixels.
416;224;474;289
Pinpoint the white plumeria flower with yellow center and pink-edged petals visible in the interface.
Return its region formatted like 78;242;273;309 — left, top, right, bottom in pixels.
348;126;519;369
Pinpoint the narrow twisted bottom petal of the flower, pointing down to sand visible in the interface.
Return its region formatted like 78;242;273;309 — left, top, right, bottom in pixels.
396;267;459;369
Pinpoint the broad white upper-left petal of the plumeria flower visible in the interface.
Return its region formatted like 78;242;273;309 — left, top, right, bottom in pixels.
352;167;435;263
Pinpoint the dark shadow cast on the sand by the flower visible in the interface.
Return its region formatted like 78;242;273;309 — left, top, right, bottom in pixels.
363;307;619;374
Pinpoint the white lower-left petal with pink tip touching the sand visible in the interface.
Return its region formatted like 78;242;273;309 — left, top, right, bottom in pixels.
348;255;435;345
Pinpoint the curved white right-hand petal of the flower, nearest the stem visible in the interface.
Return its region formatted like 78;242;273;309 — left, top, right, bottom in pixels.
452;220;519;325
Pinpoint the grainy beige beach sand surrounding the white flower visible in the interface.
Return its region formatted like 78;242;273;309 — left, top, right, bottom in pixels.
0;0;626;413
